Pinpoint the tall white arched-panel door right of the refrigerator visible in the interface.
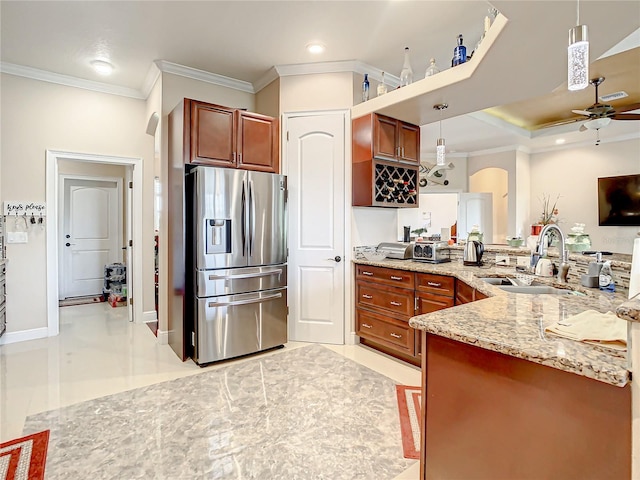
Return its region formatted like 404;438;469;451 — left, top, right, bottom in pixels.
285;113;346;344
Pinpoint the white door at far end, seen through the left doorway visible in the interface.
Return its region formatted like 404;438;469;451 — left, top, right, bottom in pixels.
61;179;122;298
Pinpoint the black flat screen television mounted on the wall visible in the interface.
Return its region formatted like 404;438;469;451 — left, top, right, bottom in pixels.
598;174;640;227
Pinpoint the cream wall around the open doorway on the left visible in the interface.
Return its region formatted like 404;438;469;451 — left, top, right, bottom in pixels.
0;74;154;333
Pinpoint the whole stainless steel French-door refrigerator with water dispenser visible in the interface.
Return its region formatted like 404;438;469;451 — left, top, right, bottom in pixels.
186;166;287;365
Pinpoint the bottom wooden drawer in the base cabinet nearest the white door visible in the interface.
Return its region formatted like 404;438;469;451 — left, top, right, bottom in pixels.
356;309;415;355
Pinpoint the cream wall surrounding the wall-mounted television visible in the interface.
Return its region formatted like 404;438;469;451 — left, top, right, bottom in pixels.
530;139;640;254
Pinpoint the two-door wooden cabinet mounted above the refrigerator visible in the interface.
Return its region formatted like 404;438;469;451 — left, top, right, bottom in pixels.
182;99;280;173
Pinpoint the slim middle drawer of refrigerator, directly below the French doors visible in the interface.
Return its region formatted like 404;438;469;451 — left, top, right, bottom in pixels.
196;265;287;298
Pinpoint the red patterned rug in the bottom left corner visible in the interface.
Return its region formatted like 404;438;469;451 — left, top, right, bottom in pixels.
0;430;49;480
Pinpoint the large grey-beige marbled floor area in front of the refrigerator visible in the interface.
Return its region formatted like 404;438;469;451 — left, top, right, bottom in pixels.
25;345;416;480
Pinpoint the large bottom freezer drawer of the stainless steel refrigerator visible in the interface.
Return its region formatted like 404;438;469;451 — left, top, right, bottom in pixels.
194;288;287;365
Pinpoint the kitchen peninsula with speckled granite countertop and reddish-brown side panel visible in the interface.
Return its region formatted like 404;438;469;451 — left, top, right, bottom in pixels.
355;260;631;479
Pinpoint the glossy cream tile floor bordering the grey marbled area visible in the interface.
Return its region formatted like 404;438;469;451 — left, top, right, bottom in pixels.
0;303;420;480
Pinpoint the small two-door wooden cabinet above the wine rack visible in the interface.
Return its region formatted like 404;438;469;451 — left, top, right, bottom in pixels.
364;113;420;164
